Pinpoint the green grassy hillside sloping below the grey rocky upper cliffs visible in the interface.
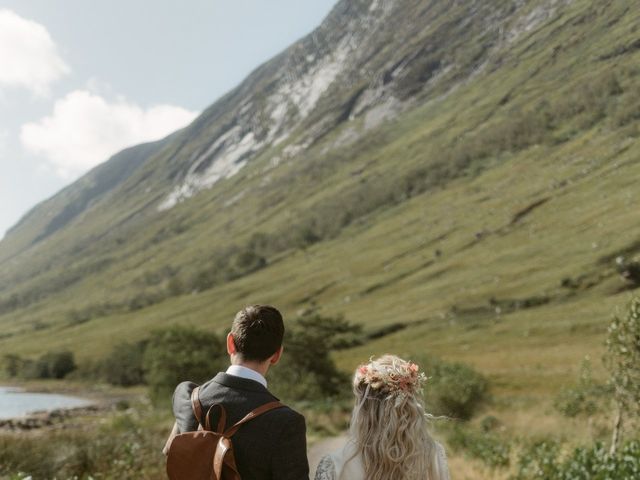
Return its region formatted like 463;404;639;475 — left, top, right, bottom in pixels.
0;0;640;466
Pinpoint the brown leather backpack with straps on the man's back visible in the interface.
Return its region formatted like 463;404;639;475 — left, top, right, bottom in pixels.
167;387;284;480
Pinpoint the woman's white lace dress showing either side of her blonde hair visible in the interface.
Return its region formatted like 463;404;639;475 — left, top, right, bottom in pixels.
315;440;449;480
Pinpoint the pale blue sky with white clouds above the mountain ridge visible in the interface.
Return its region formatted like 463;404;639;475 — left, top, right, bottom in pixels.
0;0;336;238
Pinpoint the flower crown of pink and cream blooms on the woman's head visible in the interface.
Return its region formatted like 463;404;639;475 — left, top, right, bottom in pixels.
354;357;427;394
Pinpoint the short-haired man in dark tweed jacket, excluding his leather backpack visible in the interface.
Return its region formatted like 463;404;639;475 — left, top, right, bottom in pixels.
165;305;309;480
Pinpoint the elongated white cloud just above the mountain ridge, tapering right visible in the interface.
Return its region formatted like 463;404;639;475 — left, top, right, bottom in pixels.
20;90;199;179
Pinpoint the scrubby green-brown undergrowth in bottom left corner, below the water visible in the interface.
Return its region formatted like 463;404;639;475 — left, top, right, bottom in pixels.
0;405;170;480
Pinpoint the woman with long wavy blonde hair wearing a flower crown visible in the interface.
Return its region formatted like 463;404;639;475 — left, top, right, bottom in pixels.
315;355;449;480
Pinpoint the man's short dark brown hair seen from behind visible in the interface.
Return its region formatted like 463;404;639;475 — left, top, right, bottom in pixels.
231;305;284;362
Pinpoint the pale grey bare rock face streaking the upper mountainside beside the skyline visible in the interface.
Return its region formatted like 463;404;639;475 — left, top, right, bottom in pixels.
158;1;410;210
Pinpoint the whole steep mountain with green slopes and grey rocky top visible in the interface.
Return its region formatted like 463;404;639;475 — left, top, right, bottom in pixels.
0;0;640;404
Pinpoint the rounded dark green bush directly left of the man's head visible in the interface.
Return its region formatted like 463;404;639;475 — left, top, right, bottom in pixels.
143;326;226;405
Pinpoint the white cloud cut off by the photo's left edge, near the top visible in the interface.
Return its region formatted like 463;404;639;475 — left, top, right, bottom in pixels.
0;9;70;96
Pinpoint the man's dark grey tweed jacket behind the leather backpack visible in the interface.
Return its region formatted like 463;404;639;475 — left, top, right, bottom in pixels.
173;372;309;480
